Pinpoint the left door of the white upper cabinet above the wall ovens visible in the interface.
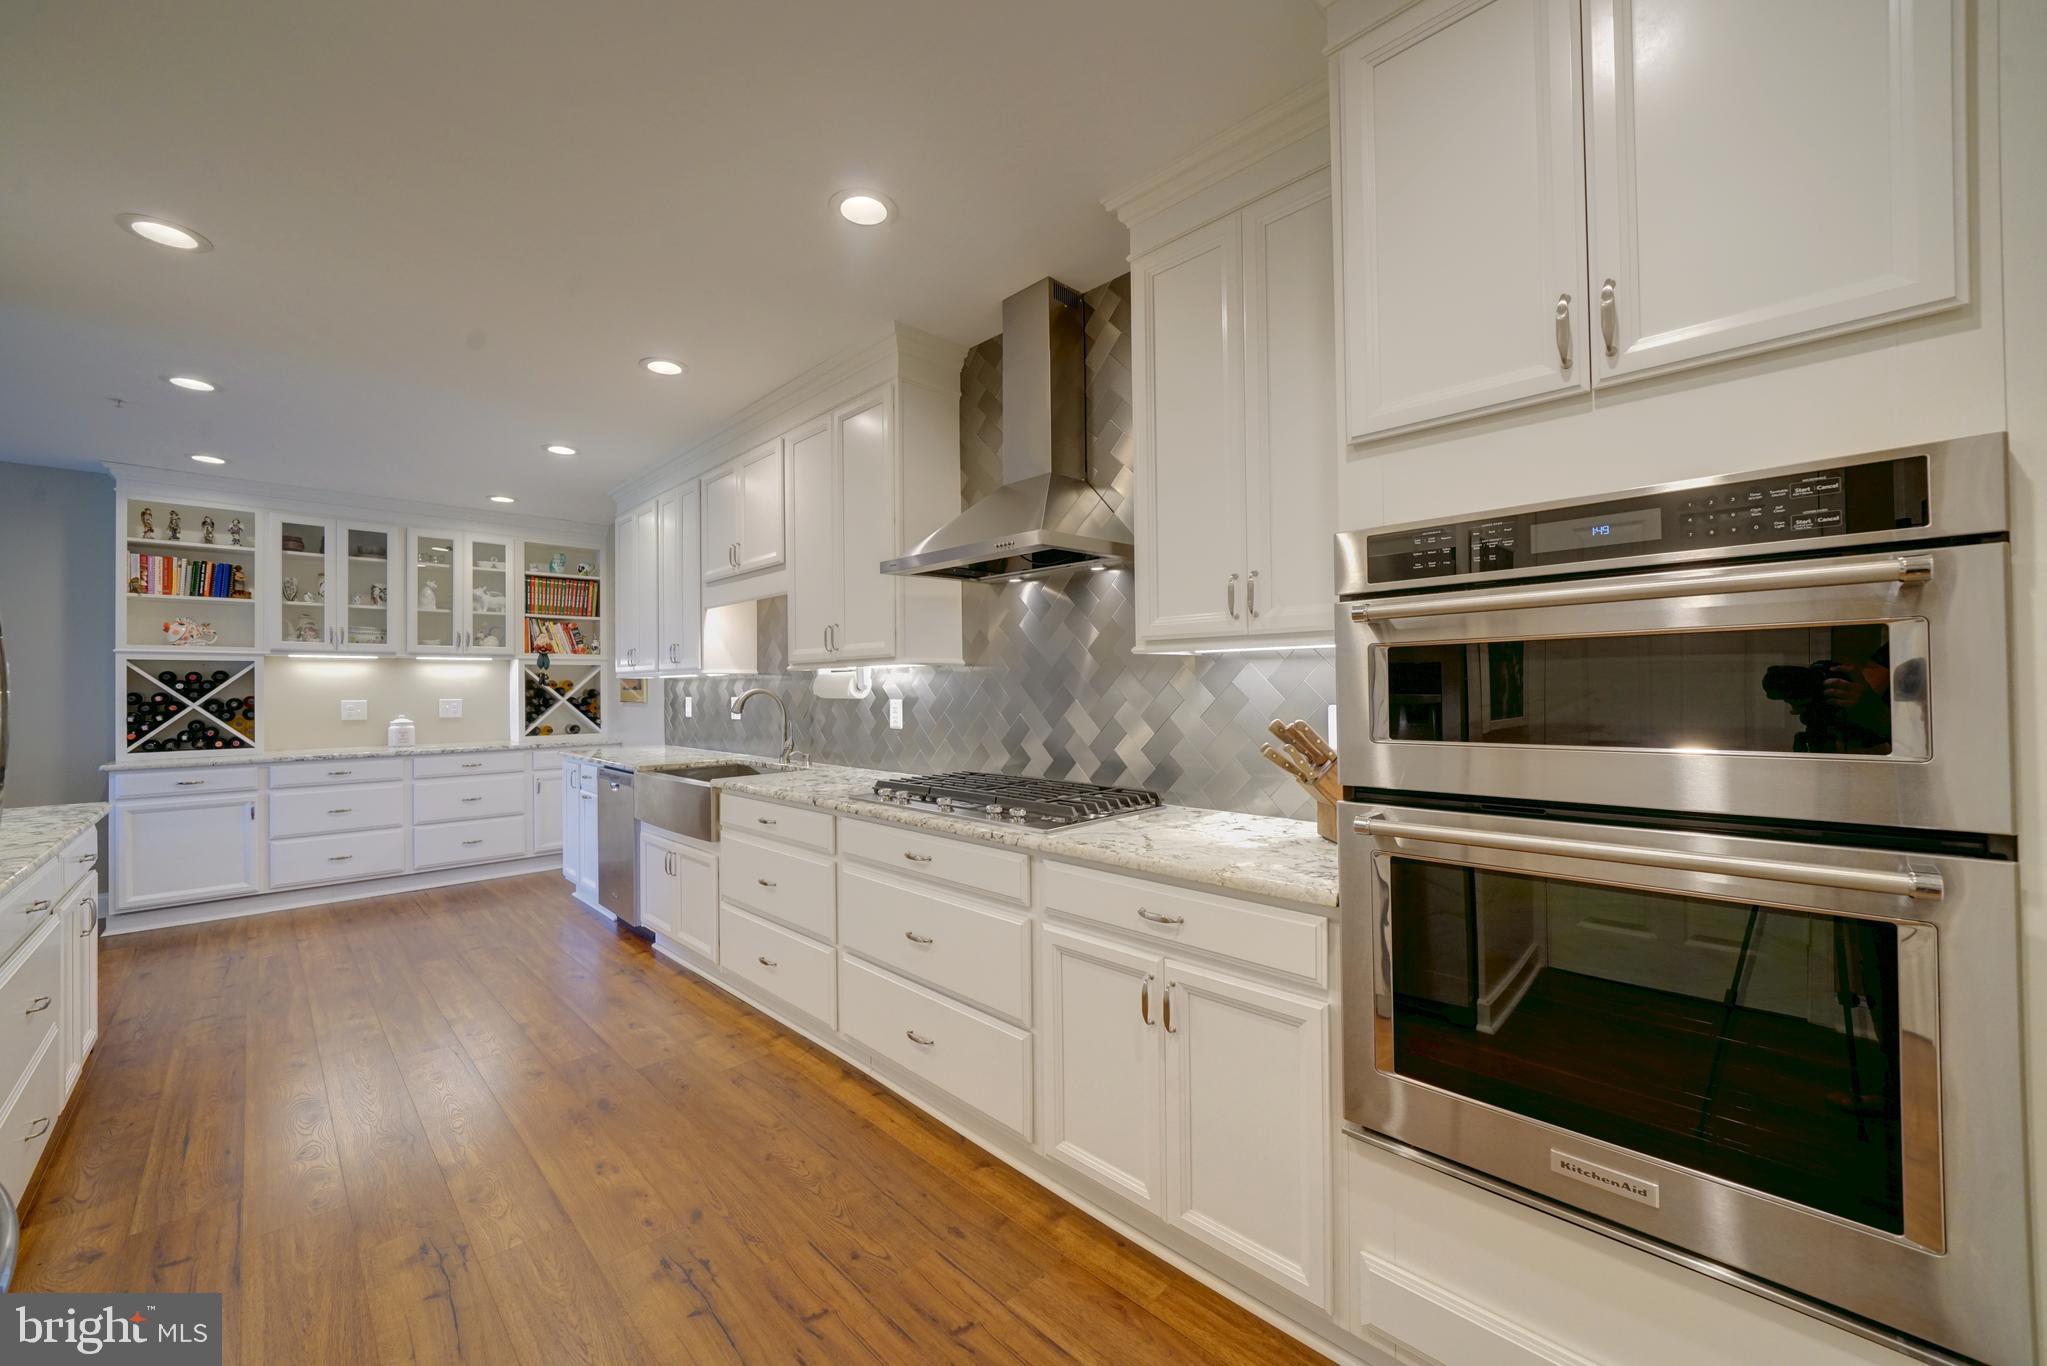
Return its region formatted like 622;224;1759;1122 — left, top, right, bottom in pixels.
1337;0;1591;440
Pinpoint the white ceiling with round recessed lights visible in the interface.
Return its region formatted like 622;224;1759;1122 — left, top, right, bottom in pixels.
0;0;1322;520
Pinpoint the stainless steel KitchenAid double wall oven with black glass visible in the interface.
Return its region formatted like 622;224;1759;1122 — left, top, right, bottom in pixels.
1339;436;2033;1362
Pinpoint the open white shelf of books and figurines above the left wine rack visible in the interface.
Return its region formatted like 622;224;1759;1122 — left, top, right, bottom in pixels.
119;498;258;655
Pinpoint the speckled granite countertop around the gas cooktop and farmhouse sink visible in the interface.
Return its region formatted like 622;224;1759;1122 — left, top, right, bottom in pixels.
577;745;1337;913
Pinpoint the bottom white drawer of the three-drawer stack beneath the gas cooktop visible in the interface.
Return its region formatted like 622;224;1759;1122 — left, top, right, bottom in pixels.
839;956;1030;1139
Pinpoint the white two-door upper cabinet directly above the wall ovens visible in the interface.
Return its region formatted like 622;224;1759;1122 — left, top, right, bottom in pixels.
1335;0;1967;440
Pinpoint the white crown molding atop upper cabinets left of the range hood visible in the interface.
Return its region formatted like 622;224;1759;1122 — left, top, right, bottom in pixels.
610;324;966;508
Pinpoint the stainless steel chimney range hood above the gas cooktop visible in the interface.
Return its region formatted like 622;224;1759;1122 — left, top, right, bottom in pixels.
882;279;1132;580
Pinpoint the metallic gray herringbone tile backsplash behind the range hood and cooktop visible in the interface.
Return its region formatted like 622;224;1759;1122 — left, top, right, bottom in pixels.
665;276;1337;817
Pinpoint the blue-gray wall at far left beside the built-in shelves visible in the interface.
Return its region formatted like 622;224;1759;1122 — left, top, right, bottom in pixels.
0;463;115;807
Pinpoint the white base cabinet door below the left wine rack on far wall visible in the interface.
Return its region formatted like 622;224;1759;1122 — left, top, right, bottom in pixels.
108;793;262;911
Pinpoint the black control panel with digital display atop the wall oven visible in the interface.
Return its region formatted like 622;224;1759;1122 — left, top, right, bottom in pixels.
1363;455;1930;584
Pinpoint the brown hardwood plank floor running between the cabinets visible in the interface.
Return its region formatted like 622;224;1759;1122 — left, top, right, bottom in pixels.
14;874;1322;1366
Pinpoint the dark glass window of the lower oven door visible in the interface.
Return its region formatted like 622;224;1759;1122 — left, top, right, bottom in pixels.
1376;852;1941;1247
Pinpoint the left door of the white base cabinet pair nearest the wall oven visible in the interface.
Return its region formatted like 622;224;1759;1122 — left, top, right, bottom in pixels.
1038;926;1165;1212
